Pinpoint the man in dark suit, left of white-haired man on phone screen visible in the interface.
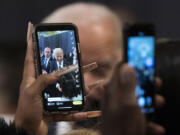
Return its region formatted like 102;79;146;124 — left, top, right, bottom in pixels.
41;47;53;74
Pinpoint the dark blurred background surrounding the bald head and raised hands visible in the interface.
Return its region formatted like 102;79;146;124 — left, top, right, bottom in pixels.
0;0;180;134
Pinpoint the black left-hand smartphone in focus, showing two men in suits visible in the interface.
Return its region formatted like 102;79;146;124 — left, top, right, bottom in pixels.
33;23;84;114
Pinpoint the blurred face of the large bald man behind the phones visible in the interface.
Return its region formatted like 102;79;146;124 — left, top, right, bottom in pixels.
79;20;121;98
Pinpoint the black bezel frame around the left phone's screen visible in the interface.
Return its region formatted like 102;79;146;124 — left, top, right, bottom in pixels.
33;23;85;113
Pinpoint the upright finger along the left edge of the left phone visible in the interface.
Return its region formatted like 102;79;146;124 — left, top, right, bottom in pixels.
23;22;35;81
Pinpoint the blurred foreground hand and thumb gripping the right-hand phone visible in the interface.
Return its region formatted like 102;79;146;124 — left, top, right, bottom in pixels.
102;63;146;135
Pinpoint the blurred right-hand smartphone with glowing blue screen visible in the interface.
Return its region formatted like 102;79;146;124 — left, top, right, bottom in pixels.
124;24;155;114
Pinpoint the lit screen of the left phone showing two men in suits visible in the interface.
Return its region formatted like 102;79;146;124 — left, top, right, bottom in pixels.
37;30;83;110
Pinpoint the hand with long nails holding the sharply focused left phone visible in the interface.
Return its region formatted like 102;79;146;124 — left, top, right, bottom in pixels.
15;23;100;135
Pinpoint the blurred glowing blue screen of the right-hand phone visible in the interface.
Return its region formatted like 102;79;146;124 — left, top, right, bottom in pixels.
128;36;155;113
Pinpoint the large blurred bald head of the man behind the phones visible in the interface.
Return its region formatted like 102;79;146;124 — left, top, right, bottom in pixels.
44;3;122;99
